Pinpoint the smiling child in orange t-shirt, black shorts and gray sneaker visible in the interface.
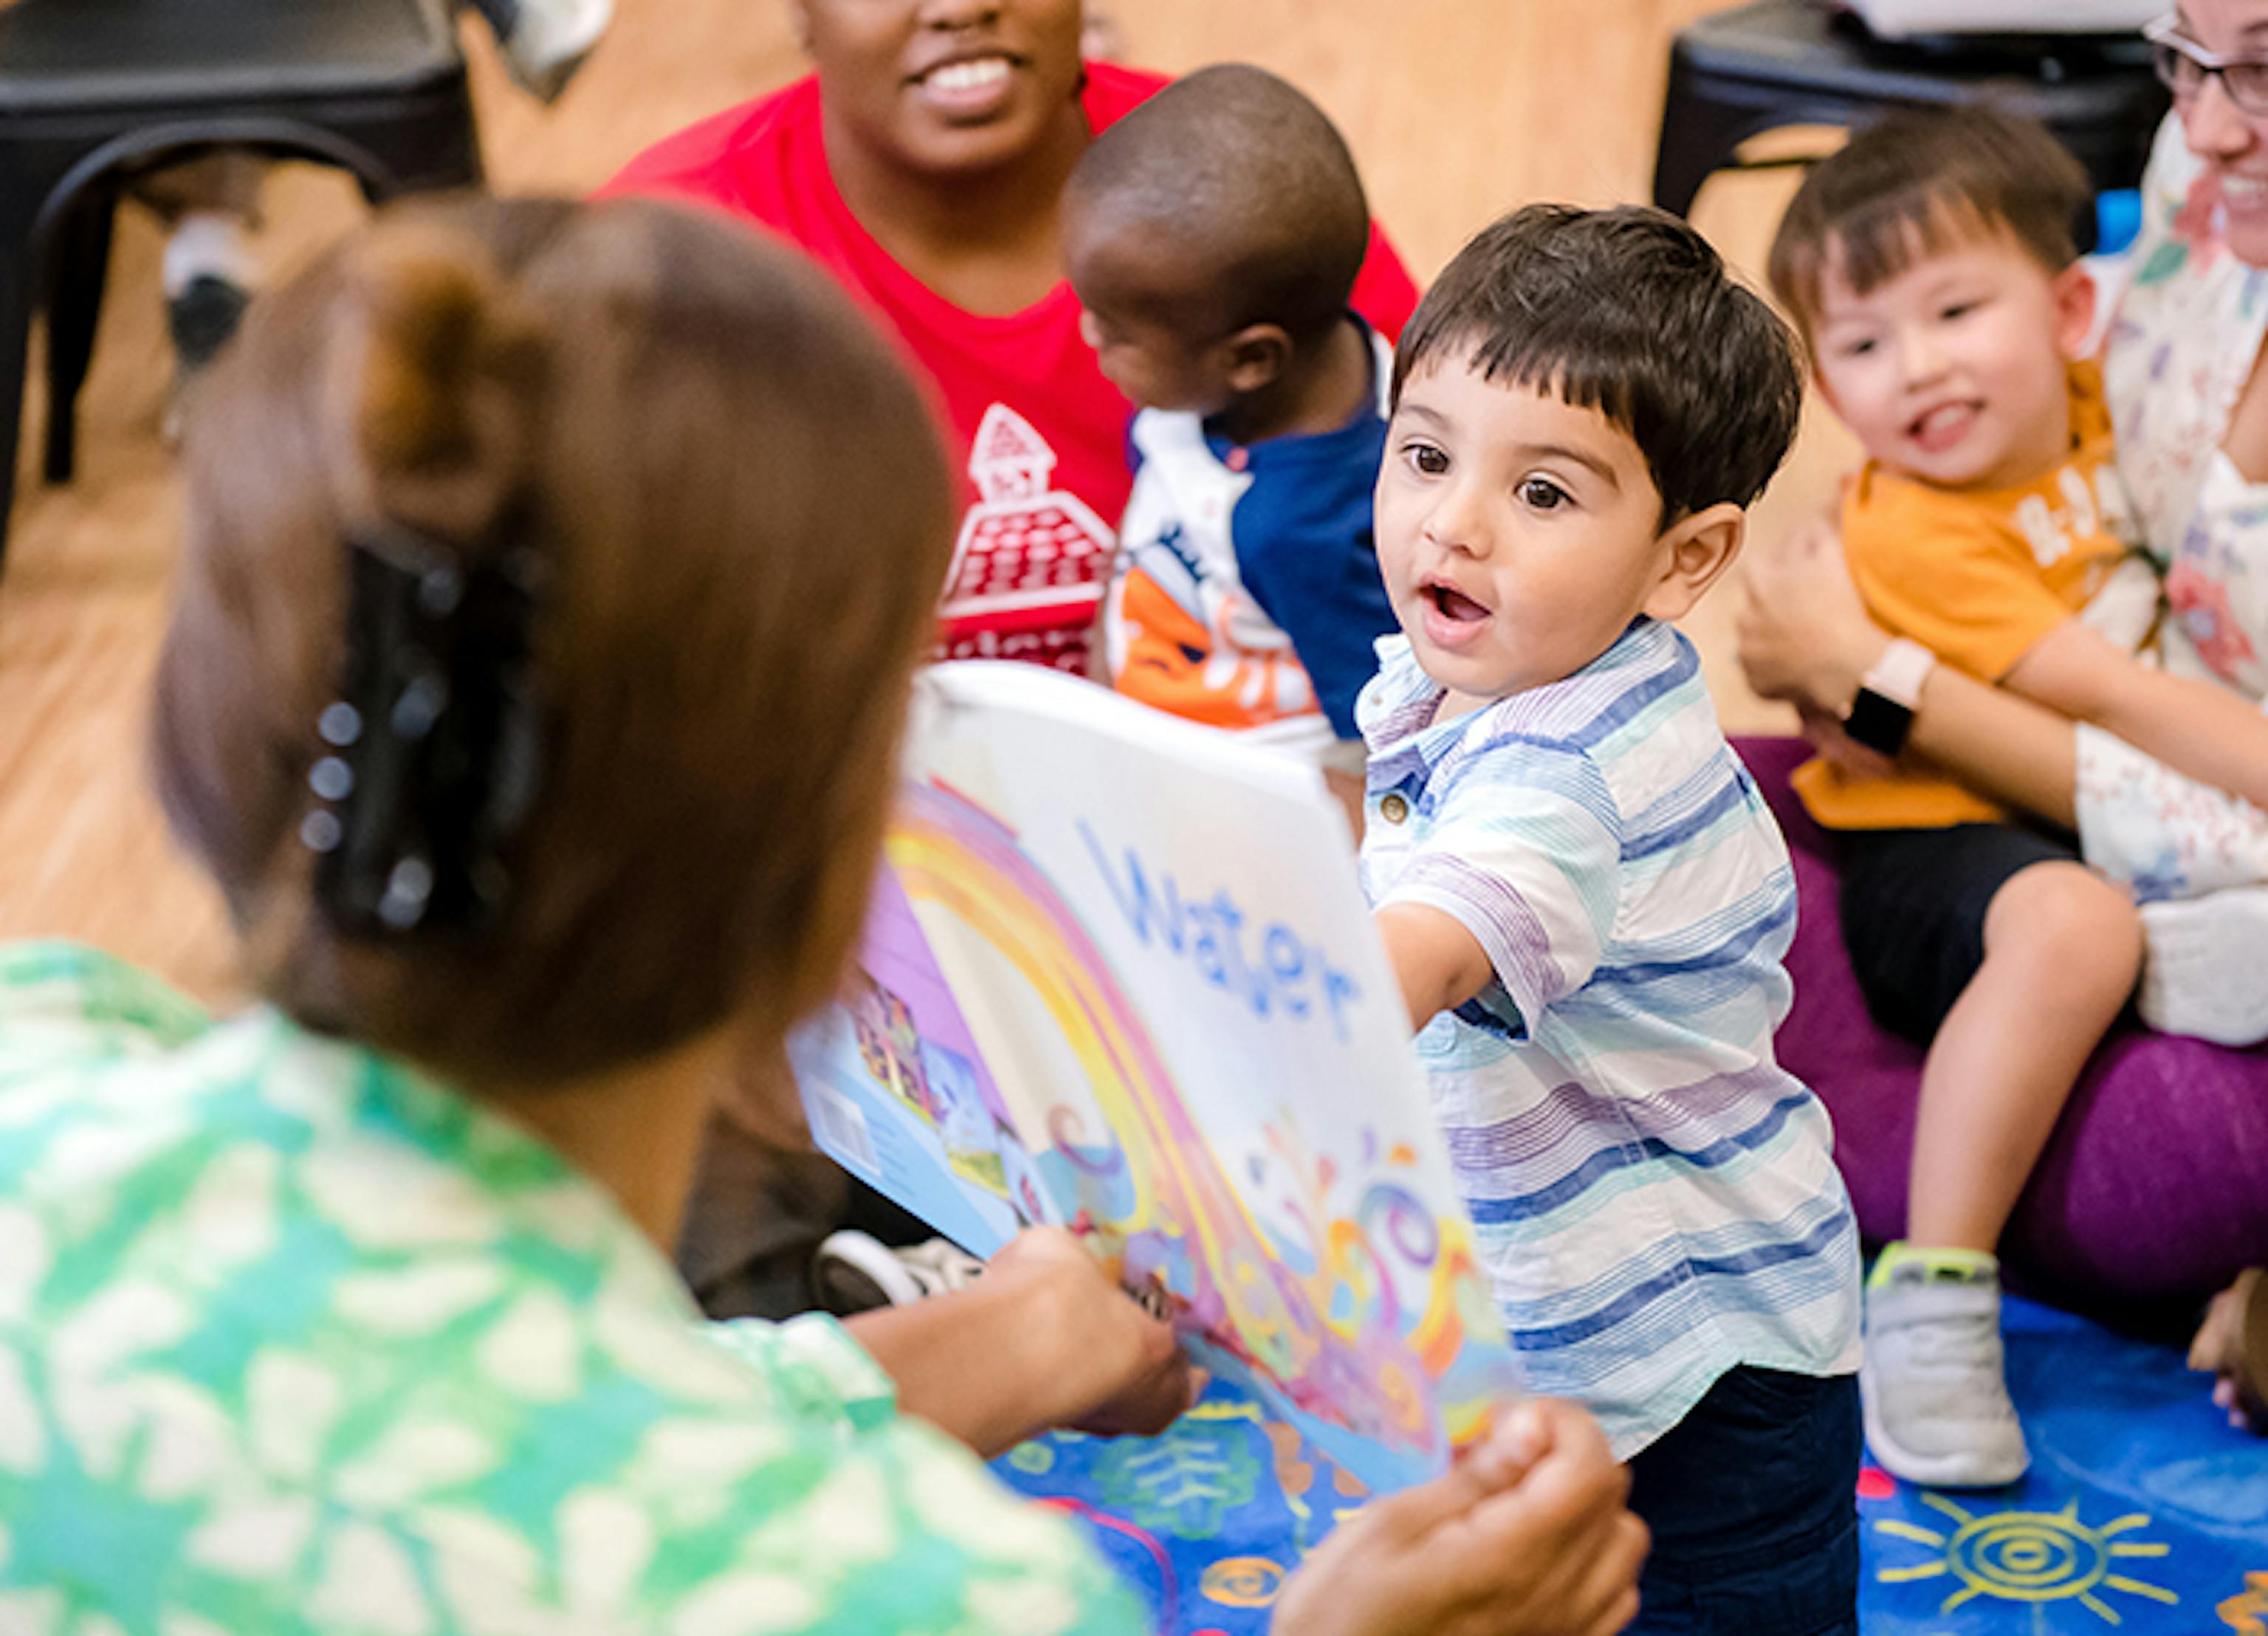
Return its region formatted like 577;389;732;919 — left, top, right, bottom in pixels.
1771;109;2268;1486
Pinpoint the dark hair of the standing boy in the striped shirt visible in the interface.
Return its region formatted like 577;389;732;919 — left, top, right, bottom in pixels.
1395;205;1803;526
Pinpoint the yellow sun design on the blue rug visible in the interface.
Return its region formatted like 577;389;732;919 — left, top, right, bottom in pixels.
1873;1493;2182;1625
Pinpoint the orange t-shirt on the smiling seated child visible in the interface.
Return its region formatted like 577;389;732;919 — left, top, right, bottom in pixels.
1794;363;2139;828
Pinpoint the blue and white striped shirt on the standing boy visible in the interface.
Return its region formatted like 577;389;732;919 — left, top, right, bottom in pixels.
1356;619;1860;1459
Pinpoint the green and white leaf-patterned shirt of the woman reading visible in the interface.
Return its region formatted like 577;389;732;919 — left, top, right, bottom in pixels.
0;944;1141;1636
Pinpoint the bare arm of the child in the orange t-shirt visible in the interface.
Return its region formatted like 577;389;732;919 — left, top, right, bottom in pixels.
2005;619;2268;808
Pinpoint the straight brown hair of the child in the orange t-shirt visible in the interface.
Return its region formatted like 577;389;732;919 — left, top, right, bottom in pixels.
1769;106;2093;334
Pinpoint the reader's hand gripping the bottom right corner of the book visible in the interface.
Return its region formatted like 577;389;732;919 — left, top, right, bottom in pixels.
1274;1398;1646;1636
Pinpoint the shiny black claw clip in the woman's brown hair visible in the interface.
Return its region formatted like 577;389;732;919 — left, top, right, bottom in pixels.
300;524;542;935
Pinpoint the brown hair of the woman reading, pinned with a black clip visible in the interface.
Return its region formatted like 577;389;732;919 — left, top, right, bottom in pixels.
154;199;950;1085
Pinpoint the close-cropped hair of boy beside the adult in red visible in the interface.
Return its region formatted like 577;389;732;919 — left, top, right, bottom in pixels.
1066;63;1370;340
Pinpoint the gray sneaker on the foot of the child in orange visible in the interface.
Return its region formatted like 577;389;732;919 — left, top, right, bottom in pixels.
1858;1259;2032;1488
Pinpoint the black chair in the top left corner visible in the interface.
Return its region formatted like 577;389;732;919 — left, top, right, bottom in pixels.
0;0;481;574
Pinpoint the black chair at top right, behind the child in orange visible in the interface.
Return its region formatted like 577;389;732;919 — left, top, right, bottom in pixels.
1653;0;2168;216
